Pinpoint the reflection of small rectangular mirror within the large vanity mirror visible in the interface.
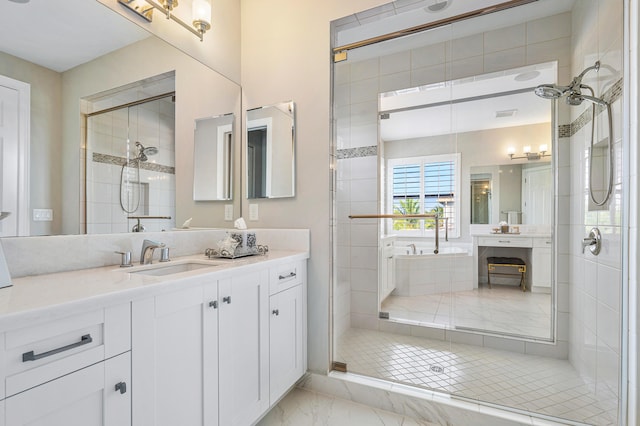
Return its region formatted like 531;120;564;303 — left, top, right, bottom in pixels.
193;113;235;201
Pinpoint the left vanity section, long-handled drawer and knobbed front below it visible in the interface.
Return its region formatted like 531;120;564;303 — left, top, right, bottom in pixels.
1;303;131;426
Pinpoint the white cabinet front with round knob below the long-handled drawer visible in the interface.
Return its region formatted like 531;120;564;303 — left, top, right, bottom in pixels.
5;353;131;426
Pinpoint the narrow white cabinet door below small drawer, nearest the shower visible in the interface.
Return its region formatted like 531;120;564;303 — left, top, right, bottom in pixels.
269;285;304;404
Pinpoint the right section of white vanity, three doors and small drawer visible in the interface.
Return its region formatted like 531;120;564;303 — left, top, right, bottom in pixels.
132;261;306;426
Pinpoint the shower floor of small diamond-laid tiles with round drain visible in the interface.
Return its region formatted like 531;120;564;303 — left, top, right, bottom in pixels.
336;328;617;425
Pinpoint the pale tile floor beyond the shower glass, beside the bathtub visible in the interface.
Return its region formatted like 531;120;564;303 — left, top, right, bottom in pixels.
381;285;551;338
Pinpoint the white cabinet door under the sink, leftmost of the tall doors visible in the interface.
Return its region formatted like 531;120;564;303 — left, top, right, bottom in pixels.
132;286;217;426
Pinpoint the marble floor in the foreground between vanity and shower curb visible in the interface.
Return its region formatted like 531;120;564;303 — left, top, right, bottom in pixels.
258;388;436;426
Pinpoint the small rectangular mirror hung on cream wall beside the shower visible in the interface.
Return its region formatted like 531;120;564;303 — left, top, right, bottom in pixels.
245;101;296;199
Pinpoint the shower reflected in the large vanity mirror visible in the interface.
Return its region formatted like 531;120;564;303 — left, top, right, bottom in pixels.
83;72;176;234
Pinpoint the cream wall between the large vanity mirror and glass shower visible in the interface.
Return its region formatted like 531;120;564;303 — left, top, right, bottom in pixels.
241;0;386;372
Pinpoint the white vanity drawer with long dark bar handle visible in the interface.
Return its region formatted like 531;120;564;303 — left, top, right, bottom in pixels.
3;304;131;396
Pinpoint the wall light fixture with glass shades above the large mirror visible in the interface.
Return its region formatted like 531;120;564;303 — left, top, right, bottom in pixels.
118;0;211;41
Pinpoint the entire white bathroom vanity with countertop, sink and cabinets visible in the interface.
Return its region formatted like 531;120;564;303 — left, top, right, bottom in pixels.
0;230;309;426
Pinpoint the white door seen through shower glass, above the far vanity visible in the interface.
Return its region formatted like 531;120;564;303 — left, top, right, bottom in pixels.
522;166;553;225
